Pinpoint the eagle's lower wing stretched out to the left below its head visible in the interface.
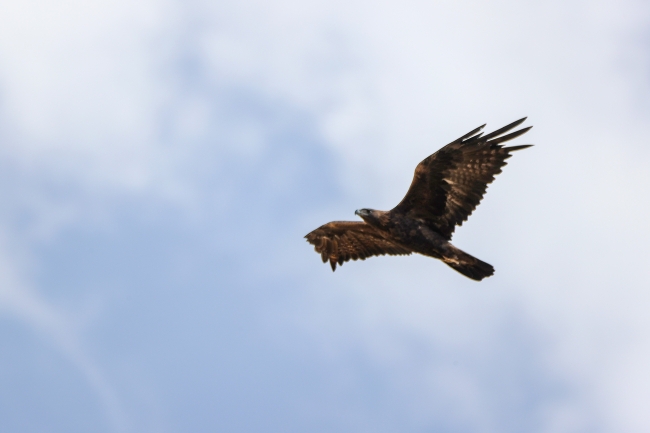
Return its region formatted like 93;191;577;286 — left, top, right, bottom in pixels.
305;221;411;271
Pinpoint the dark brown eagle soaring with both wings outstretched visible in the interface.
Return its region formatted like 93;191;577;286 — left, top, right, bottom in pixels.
305;117;532;281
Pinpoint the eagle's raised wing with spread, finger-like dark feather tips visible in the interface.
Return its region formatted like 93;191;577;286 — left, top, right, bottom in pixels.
391;117;532;239
